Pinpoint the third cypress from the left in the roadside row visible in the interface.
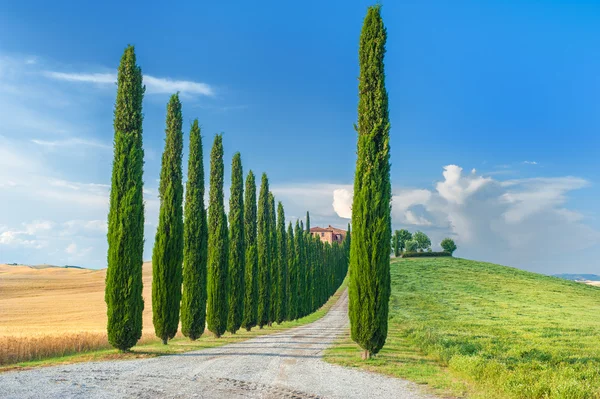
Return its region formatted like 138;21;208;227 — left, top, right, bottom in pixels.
181;119;208;341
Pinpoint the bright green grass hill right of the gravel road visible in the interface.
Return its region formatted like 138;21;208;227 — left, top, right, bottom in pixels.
326;258;600;399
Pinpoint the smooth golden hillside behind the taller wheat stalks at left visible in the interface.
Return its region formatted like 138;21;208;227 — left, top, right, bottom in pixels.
0;263;153;336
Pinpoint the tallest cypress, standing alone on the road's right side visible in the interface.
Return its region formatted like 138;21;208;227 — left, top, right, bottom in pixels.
349;5;392;358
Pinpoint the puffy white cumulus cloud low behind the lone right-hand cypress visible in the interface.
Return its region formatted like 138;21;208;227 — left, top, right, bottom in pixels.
332;165;600;272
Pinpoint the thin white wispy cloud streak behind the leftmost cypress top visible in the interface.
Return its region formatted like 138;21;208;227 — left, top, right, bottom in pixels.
43;71;215;96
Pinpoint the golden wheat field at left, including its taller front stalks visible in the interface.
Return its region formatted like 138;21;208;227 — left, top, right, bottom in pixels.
0;262;159;365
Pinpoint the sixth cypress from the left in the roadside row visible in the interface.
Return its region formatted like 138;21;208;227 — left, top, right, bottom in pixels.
242;171;258;331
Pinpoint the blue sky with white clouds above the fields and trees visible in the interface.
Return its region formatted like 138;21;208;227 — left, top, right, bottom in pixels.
0;0;600;273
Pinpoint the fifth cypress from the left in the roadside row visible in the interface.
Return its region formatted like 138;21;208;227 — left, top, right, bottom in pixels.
227;152;246;334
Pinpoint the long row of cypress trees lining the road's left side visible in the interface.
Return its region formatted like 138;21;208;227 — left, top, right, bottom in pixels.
105;46;351;350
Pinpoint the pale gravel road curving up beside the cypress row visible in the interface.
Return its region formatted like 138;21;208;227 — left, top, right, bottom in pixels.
0;292;433;399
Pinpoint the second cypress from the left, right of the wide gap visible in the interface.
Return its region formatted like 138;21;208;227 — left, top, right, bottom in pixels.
152;94;183;345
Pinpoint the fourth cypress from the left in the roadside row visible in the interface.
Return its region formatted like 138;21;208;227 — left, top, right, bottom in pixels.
206;134;229;338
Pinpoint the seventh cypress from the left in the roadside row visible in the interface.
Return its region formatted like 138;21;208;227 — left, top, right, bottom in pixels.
257;173;271;328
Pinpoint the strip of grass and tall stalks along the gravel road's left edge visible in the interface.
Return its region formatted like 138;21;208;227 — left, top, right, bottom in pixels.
0;281;347;372
